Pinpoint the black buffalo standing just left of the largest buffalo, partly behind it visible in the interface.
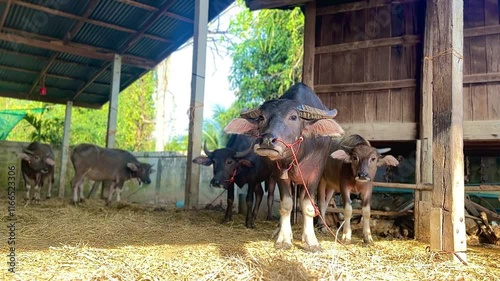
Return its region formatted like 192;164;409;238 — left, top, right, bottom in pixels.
193;135;276;228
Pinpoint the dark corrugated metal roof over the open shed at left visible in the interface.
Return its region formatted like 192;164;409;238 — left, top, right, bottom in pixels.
0;0;234;107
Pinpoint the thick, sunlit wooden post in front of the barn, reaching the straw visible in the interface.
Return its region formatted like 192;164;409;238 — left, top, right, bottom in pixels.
428;0;467;260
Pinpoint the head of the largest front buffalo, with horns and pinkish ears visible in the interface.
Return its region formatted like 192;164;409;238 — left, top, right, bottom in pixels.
224;99;344;160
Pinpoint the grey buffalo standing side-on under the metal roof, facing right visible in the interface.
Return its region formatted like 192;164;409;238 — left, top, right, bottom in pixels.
71;143;155;205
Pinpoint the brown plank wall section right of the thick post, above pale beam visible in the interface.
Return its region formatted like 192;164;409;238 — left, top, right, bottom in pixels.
464;0;500;121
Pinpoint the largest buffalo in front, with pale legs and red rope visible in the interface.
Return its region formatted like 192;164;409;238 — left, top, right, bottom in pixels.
224;83;344;251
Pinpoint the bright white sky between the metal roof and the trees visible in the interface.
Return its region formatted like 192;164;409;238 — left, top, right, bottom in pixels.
158;3;240;135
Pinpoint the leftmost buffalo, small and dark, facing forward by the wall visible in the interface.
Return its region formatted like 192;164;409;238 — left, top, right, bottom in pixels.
18;142;55;203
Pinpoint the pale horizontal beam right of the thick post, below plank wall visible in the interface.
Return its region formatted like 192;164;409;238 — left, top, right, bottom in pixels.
463;120;500;141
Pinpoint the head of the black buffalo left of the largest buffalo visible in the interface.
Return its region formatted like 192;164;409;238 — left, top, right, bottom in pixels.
193;140;254;188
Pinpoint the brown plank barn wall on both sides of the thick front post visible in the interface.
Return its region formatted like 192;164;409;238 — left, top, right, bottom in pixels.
304;0;500;142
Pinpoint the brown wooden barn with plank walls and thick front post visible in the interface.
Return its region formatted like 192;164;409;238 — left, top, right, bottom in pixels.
246;0;500;260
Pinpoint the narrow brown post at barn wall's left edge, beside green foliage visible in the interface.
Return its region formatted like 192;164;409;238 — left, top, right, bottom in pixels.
302;1;316;89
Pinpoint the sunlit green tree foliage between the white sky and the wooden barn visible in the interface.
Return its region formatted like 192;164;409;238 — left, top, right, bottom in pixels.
229;0;304;108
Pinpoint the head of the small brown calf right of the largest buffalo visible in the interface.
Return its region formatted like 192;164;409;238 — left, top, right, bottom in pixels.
330;144;399;182
